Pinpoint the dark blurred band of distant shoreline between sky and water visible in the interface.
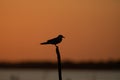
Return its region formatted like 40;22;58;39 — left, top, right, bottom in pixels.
0;61;120;70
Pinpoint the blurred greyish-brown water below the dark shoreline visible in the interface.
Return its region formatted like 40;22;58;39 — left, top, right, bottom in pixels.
0;69;120;80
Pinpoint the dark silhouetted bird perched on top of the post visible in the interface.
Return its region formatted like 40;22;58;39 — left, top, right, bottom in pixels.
40;35;65;46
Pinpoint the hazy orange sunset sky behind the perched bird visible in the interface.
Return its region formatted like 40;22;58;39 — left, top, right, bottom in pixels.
0;0;120;62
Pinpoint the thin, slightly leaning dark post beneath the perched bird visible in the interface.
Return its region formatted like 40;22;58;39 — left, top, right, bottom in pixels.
56;46;62;80
